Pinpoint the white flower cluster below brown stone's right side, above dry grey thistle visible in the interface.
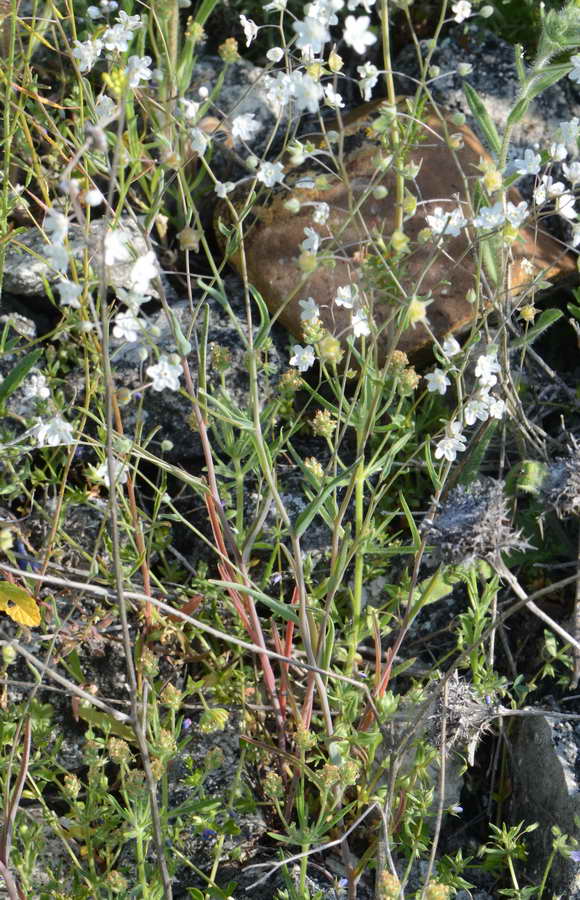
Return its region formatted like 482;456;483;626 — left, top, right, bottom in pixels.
425;336;505;462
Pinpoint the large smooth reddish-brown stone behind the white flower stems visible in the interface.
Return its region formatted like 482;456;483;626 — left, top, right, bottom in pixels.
218;101;577;358
